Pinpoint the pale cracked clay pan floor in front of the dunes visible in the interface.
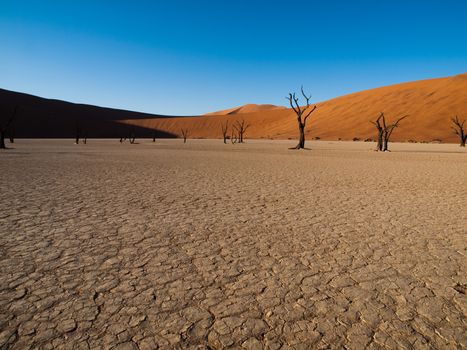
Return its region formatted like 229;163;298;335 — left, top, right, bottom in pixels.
0;140;467;350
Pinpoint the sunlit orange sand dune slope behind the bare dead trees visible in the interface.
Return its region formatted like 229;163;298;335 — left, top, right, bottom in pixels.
122;74;467;142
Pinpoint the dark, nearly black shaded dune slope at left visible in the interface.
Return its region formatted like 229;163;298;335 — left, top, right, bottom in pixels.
0;89;180;138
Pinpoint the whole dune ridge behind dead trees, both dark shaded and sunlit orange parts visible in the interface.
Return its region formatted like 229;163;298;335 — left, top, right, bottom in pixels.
0;74;467;142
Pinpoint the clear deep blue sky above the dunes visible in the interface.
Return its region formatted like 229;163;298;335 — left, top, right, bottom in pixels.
0;0;467;115
